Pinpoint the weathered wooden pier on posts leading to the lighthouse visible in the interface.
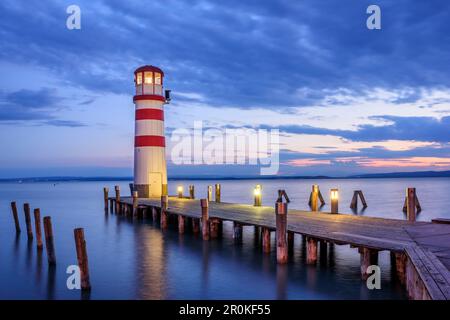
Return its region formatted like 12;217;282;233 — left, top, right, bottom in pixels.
106;196;450;300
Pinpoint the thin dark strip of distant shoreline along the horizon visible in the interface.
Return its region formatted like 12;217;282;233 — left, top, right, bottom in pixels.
0;171;450;182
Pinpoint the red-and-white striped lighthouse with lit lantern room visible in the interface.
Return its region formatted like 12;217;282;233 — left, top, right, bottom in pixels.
133;66;169;198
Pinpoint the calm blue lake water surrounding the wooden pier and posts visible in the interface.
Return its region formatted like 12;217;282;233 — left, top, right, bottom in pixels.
0;178;450;299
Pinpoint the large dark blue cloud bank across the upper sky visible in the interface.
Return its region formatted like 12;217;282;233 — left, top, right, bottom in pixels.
0;0;450;108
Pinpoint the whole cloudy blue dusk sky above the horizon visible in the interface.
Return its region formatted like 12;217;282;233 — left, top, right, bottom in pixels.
0;0;450;178
